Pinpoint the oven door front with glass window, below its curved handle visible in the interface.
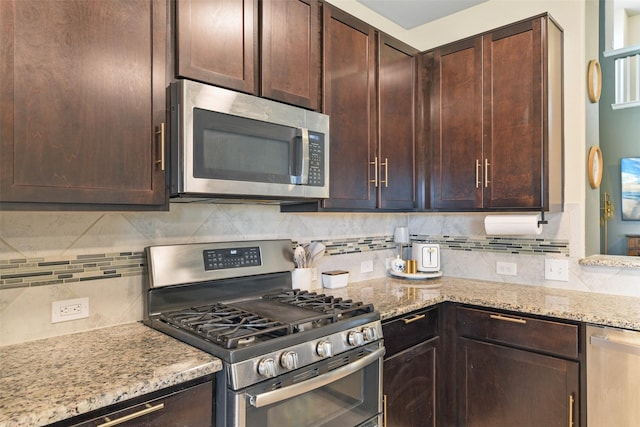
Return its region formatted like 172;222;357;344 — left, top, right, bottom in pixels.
246;362;381;427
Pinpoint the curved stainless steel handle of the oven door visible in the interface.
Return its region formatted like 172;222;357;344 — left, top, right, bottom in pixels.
248;347;385;408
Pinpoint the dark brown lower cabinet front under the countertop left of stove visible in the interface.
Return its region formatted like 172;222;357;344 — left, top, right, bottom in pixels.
49;377;215;427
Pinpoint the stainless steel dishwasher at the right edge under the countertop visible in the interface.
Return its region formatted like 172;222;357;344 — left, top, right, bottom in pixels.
587;326;640;427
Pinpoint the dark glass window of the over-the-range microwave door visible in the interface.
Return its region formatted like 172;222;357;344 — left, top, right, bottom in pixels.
193;108;296;184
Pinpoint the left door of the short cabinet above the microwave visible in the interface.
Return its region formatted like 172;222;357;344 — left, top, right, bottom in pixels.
176;0;258;95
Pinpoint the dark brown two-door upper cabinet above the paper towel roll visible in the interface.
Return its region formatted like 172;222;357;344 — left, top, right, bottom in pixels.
428;15;564;211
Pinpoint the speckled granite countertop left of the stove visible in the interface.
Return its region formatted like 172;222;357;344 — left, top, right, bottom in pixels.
0;323;222;427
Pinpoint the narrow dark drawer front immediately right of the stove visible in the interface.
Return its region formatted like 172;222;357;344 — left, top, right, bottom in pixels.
382;307;438;357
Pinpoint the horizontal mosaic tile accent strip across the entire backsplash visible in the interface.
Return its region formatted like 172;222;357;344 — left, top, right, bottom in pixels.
0;234;569;289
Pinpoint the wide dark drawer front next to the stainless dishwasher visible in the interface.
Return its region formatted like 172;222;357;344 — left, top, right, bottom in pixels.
456;307;579;359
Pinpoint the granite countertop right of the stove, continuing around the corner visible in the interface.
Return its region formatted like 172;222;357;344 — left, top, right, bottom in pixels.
323;277;640;330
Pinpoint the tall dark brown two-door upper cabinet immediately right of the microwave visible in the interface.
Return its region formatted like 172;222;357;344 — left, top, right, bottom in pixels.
321;4;417;211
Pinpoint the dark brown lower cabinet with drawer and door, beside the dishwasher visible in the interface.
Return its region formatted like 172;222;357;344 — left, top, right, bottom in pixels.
455;306;585;427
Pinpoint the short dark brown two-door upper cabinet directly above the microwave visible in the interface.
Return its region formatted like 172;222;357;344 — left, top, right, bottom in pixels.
176;0;321;110
